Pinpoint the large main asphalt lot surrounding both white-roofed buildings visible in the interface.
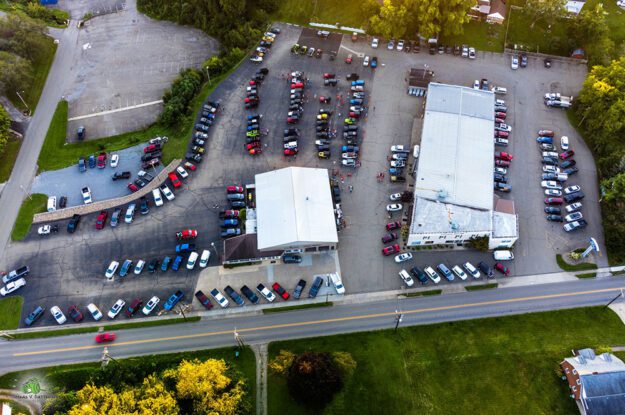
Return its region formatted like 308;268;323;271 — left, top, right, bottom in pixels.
4;25;603;324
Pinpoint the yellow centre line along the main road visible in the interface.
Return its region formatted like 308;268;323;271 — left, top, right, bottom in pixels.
13;287;625;357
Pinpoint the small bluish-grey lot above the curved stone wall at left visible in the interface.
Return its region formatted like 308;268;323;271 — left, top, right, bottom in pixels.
31;143;162;207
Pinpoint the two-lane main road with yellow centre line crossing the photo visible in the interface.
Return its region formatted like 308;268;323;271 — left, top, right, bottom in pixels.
0;277;625;373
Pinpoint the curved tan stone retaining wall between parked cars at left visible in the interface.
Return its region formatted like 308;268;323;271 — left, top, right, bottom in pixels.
33;159;182;224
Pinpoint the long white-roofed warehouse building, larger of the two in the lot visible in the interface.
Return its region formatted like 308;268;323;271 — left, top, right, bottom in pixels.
408;83;518;248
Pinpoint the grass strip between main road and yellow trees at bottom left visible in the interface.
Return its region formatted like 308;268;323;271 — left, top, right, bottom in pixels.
0;347;256;413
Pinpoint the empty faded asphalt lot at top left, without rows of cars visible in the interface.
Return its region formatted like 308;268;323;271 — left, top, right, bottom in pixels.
65;0;218;141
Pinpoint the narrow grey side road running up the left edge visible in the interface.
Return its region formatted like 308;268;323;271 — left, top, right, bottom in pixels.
0;24;80;268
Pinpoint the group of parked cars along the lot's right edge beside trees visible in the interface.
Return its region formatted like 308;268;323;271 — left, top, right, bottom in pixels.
536;129;588;232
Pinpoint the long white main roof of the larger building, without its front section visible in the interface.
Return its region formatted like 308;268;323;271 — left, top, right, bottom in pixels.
415;83;495;210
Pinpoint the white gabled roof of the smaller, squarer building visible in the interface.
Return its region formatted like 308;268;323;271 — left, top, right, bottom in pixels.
256;167;338;250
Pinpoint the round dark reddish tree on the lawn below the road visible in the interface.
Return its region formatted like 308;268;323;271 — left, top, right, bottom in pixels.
287;352;343;410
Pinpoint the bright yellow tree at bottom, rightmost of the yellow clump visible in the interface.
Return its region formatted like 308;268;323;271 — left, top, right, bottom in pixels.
163;359;245;415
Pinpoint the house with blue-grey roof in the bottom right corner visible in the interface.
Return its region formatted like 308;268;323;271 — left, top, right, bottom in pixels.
560;349;625;415
